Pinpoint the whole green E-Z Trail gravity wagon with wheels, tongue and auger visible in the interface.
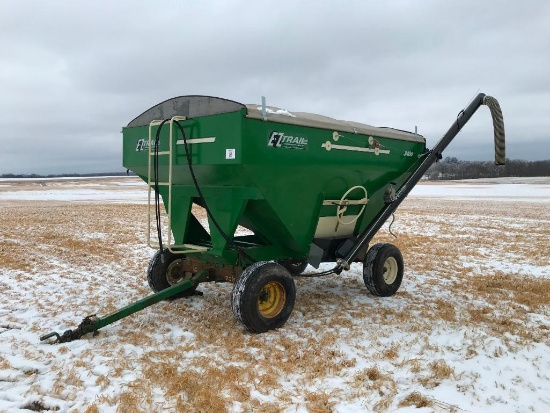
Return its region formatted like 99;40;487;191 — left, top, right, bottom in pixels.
38;94;504;341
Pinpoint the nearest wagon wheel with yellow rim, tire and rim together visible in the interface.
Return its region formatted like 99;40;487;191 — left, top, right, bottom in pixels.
231;261;296;333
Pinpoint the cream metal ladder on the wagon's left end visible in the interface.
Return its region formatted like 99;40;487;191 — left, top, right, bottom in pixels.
147;116;208;254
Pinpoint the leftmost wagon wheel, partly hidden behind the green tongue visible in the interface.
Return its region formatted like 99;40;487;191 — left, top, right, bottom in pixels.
147;249;197;299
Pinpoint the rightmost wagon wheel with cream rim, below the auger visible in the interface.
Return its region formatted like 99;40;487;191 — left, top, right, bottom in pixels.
363;244;404;297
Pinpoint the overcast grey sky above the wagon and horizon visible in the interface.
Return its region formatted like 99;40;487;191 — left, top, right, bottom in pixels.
0;0;550;174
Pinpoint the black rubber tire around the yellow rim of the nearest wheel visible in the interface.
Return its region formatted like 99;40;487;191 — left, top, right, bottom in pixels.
231;261;296;333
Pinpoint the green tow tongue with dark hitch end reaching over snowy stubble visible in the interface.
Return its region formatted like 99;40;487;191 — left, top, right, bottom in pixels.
40;270;208;344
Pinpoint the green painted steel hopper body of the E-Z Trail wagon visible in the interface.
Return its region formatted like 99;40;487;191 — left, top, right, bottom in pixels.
123;101;425;264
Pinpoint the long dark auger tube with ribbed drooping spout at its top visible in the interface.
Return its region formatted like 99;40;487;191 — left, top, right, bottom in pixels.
335;93;506;273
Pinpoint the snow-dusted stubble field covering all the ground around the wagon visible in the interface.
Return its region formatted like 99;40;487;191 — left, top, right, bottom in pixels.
0;177;550;413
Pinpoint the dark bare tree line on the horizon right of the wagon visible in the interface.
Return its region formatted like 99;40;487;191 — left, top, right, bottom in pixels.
425;157;550;180
